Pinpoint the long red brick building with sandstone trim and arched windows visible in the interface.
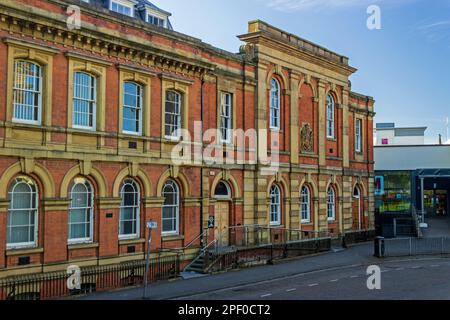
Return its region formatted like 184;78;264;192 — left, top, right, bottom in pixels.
0;0;374;277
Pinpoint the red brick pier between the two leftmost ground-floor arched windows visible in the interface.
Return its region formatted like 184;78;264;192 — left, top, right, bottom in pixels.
41;199;70;264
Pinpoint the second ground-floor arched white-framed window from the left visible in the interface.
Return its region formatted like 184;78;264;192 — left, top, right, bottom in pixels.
69;178;94;243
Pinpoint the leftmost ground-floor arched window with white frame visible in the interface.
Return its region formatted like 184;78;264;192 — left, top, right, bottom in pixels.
6;177;38;248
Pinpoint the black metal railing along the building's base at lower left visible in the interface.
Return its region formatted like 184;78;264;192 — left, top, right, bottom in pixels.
0;255;181;300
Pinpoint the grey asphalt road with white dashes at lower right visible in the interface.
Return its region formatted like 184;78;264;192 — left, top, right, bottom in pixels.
179;259;450;300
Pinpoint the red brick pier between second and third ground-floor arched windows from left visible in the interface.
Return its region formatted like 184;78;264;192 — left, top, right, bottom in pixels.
94;198;121;257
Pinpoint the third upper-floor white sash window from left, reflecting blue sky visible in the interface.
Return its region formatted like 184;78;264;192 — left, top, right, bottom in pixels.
122;82;142;134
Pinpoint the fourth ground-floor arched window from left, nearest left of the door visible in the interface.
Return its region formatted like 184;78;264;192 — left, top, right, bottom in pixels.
162;180;180;234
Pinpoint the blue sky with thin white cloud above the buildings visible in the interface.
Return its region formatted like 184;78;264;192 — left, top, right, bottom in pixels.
153;0;450;142
